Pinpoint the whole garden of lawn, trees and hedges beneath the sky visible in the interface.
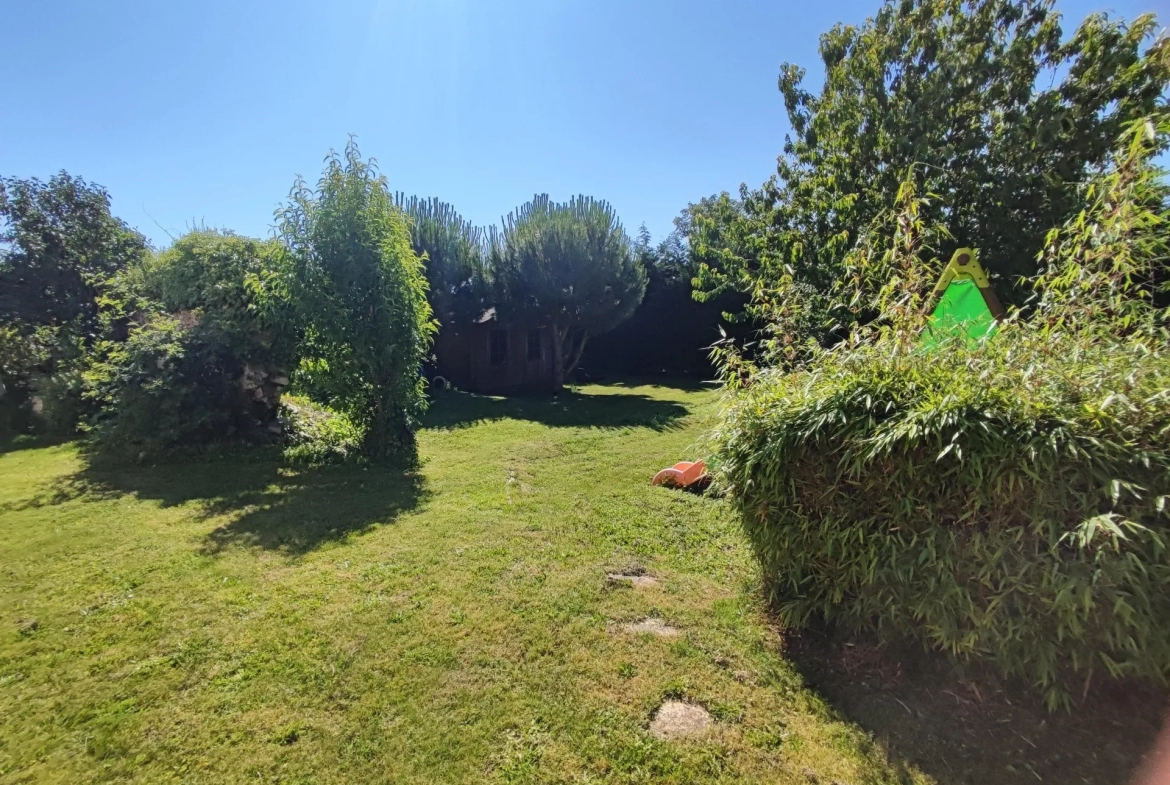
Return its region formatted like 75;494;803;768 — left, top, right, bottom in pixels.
0;0;1170;784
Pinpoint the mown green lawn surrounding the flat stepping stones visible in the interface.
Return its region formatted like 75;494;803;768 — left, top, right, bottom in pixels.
0;385;928;785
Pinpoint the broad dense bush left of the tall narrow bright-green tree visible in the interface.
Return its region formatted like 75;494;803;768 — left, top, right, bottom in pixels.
83;232;296;457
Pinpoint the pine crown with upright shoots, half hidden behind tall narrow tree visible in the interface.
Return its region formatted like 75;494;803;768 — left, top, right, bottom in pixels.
394;192;489;325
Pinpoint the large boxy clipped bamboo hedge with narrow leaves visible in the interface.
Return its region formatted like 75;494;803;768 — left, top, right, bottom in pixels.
715;323;1170;705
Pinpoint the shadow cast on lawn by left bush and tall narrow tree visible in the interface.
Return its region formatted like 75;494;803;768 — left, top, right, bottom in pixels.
61;450;426;555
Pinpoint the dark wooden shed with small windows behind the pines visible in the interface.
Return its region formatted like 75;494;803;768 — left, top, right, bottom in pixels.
434;308;553;394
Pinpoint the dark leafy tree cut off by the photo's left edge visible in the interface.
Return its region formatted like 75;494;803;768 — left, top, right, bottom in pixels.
0;172;146;339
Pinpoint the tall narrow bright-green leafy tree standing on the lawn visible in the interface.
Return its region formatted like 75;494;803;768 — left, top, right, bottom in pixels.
277;140;435;460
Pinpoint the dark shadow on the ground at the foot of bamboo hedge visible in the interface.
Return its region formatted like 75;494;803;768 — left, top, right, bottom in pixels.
785;627;1166;785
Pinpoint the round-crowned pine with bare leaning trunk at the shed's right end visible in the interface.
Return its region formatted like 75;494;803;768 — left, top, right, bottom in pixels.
491;194;646;390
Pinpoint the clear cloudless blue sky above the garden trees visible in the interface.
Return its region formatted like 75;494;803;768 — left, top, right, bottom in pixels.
0;0;1170;246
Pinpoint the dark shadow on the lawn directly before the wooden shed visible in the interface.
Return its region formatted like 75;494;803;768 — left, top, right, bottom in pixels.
422;390;688;431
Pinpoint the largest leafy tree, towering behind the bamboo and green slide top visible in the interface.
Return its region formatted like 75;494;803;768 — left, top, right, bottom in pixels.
689;0;1170;342
